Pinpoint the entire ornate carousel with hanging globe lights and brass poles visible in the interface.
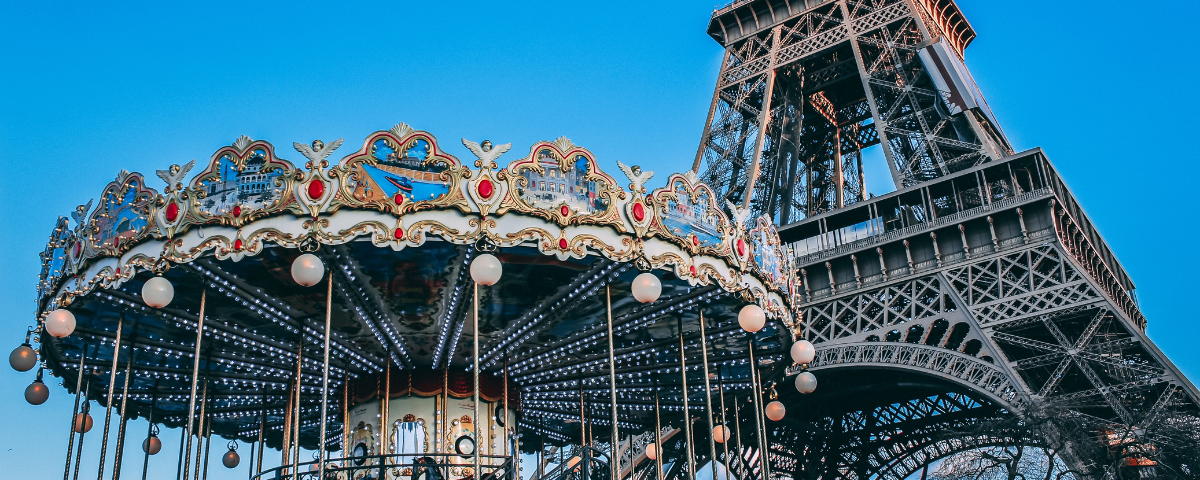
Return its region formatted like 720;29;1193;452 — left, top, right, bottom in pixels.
10;124;816;480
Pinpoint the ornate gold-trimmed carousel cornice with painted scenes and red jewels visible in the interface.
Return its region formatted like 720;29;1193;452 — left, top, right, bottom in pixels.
38;124;799;337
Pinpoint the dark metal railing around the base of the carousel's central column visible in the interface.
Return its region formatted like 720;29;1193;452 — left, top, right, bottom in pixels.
251;454;518;480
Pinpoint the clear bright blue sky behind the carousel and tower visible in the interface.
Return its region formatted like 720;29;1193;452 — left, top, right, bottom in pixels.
0;0;1200;479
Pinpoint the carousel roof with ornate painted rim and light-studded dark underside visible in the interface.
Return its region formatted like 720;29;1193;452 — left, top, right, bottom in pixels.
38;124;799;445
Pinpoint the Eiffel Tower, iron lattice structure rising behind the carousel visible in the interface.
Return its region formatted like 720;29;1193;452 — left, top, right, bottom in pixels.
692;0;1200;479
